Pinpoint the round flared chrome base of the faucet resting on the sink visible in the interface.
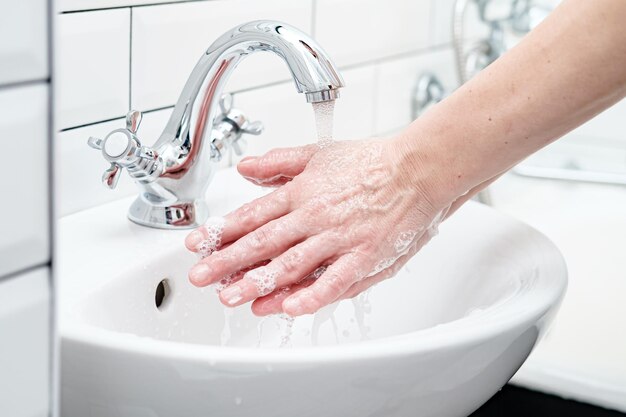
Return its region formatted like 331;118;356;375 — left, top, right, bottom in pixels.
128;196;209;230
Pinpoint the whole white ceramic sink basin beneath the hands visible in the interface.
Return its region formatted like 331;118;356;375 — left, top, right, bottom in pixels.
57;170;567;417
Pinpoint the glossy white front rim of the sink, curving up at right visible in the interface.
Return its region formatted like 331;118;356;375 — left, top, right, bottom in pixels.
60;218;567;364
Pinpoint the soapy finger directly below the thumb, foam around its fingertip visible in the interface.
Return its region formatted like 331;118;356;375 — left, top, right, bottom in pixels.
185;188;290;255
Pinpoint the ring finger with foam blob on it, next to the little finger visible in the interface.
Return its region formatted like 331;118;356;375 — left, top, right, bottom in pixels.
220;235;337;307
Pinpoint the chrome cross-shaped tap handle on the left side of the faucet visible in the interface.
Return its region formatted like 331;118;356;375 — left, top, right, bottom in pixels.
87;110;162;189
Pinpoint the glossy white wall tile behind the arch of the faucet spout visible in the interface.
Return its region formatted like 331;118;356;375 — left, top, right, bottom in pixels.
132;0;312;110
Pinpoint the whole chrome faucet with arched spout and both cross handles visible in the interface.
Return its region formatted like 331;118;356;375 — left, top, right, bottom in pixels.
88;21;344;229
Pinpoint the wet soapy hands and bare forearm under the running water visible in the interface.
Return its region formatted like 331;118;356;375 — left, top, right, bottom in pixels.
186;0;626;316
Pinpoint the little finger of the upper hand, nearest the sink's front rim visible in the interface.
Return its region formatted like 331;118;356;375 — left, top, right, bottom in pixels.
283;253;368;317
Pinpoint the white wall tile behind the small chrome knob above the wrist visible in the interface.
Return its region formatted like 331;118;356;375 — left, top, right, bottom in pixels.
375;48;457;133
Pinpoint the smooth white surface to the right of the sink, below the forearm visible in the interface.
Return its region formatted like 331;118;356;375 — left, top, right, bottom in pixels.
498;174;626;411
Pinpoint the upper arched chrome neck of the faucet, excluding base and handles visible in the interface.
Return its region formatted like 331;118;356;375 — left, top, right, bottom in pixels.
155;21;344;165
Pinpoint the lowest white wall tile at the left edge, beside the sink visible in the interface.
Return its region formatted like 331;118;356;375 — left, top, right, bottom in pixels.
0;268;51;417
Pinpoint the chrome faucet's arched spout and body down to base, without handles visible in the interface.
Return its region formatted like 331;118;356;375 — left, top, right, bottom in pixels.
123;21;344;229
